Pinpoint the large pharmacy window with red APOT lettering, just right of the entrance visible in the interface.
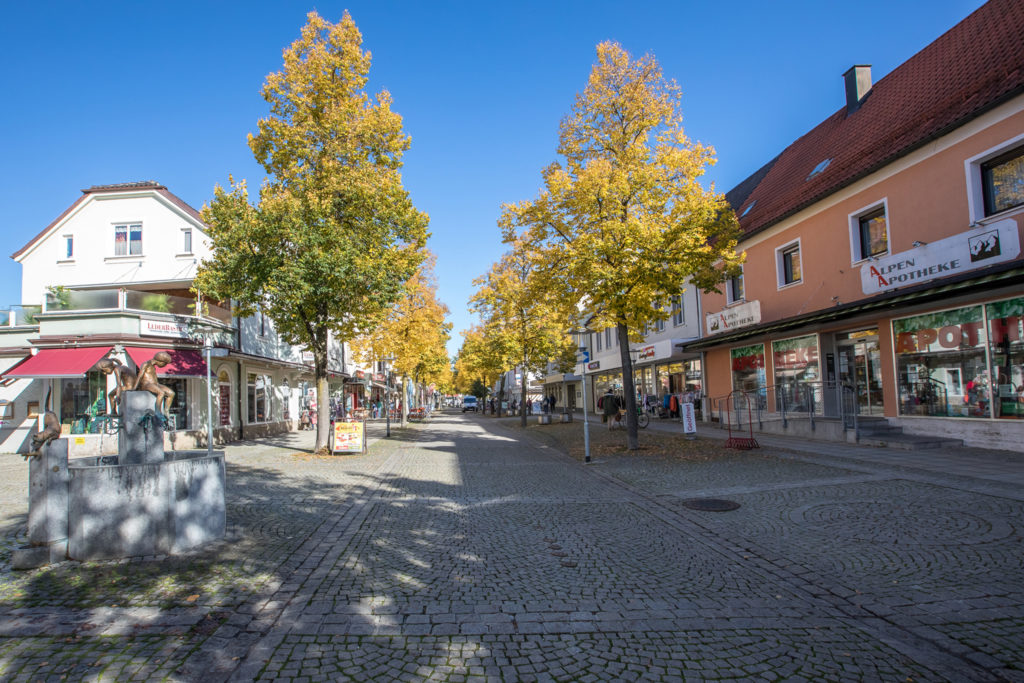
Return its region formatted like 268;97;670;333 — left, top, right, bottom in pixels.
893;306;991;418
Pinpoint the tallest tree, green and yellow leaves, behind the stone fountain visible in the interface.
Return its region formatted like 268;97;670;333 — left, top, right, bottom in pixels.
196;12;428;450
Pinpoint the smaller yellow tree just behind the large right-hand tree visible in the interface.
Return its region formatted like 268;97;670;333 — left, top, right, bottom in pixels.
470;242;572;427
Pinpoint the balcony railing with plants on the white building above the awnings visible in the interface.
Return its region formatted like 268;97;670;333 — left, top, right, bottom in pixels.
37;289;231;326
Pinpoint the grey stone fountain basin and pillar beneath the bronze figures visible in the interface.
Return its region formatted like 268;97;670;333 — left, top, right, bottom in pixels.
11;387;225;569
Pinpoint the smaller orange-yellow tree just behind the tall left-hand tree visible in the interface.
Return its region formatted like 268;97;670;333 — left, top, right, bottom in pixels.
352;252;452;425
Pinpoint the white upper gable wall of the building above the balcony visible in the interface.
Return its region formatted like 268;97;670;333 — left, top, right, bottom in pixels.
19;190;210;305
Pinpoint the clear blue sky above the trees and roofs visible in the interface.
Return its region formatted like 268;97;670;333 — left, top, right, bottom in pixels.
0;0;982;352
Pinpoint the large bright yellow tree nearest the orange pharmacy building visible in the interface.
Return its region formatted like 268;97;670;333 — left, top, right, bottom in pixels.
502;42;741;449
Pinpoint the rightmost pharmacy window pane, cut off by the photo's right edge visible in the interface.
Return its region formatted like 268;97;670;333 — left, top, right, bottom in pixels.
985;297;1024;420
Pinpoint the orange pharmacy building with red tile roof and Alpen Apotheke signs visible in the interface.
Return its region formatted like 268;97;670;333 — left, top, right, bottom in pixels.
687;0;1024;450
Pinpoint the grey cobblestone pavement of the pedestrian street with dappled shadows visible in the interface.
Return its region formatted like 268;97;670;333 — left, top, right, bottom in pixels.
0;414;1024;682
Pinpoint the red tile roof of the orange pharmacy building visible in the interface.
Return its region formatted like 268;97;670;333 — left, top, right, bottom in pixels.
728;0;1024;234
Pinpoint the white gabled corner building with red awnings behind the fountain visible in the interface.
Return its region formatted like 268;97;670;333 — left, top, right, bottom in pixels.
0;181;355;455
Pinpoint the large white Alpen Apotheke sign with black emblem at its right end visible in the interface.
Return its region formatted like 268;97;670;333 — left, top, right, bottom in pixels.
860;218;1021;294
